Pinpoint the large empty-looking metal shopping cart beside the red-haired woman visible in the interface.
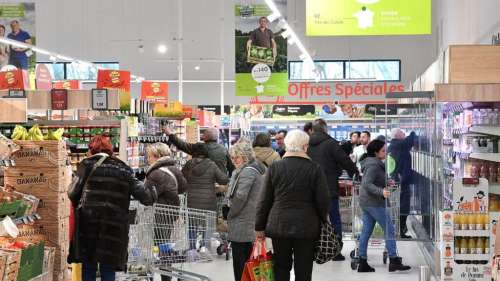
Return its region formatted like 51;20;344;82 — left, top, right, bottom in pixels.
124;197;216;281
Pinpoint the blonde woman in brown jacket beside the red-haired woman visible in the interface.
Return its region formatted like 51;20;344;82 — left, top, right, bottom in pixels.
145;142;187;206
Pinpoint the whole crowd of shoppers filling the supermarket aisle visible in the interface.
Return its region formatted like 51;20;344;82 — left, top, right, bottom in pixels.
68;119;416;281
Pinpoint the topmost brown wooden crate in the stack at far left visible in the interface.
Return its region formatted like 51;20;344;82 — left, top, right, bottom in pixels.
11;141;68;168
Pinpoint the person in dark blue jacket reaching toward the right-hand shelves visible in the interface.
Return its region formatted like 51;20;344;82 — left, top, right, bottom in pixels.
388;129;417;239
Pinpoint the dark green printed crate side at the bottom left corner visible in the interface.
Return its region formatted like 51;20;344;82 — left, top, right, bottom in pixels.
17;242;45;281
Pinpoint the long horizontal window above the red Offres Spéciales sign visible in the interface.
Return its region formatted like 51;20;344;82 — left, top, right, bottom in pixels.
288;60;401;81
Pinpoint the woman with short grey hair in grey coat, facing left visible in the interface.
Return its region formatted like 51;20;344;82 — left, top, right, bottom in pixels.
227;141;266;281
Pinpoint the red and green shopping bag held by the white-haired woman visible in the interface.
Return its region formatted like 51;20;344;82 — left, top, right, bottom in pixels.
241;240;274;281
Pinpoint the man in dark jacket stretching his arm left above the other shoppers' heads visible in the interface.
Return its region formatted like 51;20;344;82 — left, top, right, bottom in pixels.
165;128;234;175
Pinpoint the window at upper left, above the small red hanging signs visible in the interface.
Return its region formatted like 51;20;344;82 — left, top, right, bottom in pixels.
38;62;120;81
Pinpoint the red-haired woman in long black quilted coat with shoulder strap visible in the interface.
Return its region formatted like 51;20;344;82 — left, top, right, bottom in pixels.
68;136;157;281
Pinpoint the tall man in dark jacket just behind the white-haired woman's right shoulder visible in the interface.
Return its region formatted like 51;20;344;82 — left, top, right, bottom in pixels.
308;119;358;260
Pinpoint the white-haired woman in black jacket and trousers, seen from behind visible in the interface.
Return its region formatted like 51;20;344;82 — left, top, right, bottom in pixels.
255;130;330;281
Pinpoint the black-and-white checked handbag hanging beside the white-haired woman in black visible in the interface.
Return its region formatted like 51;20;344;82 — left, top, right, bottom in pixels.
314;221;342;264
